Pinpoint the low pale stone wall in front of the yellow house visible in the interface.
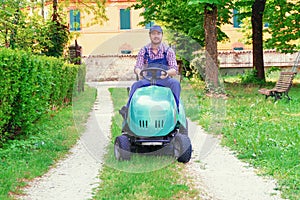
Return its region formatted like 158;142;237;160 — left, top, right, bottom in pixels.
83;51;299;82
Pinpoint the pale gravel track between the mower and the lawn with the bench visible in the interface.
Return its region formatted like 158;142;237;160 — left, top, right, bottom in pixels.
187;121;281;200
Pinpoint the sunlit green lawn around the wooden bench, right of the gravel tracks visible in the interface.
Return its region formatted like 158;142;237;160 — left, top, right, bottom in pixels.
182;72;300;200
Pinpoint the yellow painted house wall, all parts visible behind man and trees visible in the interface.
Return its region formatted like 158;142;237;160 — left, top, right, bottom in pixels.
38;0;300;56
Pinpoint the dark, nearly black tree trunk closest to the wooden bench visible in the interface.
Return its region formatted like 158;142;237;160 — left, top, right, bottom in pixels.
251;0;266;81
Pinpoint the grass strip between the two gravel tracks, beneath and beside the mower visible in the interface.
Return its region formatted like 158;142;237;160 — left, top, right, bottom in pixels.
94;88;199;200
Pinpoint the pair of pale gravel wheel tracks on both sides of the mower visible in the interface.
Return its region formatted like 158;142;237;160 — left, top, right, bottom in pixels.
21;82;280;200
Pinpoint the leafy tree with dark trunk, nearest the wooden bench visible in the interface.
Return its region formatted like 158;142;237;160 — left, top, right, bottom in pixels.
235;0;300;81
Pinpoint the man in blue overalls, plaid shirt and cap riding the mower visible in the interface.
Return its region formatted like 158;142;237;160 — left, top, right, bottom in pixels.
120;25;181;119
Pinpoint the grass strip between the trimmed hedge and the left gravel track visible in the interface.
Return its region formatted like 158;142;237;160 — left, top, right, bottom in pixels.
0;85;96;200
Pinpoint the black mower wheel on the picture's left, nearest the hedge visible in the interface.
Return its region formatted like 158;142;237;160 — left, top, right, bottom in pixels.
114;135;131;160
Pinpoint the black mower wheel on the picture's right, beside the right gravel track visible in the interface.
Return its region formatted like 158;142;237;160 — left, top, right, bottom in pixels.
174;133;192;163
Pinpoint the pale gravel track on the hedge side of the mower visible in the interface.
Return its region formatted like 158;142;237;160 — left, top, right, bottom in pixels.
20;82;113;200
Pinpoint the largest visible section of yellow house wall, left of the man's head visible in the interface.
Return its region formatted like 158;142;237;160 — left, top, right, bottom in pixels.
70;2;149;56
